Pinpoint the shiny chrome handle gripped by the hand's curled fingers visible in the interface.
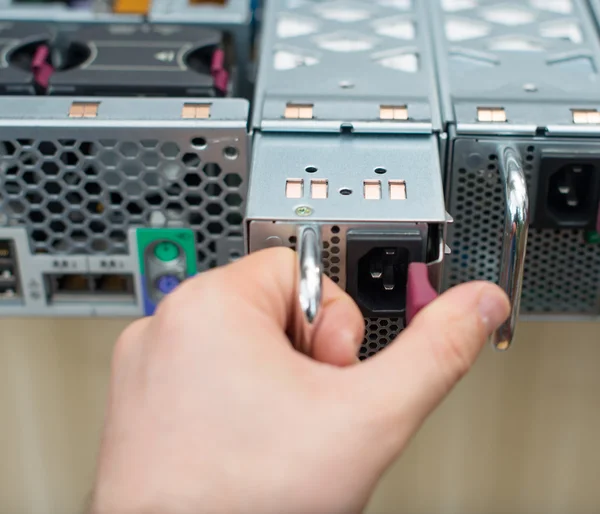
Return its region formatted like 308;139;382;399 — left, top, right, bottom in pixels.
297;225;323;325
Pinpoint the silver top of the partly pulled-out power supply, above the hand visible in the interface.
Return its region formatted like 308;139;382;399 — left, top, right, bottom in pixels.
246;132;446;224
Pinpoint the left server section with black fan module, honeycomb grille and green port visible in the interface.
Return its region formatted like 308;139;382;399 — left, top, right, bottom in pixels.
0;12;250;316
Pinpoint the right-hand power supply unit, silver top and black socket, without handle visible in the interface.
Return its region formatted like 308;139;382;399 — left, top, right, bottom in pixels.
432;0;600;318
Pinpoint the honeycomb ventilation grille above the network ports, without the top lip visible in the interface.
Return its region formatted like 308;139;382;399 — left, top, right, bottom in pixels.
0;129;247;269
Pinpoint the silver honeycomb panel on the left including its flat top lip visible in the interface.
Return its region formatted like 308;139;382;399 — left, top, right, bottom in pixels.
0;96;248;270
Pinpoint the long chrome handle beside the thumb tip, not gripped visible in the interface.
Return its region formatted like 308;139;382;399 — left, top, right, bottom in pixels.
492;147;529;351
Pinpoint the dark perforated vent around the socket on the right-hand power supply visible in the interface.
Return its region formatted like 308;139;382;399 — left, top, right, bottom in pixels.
446;140;600;315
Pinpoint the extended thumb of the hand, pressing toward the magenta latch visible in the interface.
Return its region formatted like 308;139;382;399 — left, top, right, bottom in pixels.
355;282;510;437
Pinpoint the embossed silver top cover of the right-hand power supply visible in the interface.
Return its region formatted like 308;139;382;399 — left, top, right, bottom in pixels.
423;0;600;127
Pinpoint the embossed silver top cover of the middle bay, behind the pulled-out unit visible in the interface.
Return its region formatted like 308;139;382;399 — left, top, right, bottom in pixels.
248;0;441;132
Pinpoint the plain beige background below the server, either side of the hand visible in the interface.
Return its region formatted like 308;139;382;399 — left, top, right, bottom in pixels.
0;320;600;514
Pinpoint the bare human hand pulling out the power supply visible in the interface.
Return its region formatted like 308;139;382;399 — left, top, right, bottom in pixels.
92;249;509;514
